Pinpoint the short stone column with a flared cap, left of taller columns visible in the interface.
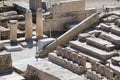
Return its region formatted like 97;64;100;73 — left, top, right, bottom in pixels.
9;20;18;41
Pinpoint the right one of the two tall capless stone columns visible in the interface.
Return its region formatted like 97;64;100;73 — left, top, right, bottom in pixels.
36;8;43;37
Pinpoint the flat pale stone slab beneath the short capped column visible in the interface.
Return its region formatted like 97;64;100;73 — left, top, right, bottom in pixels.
4;42;23;52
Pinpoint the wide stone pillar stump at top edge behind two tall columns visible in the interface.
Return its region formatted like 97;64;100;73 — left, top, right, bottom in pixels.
29;0;42;10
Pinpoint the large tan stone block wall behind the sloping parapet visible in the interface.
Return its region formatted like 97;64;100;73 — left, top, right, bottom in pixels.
44;0;96;32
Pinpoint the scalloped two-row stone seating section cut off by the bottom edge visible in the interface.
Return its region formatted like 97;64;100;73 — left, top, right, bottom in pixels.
86;62;114;80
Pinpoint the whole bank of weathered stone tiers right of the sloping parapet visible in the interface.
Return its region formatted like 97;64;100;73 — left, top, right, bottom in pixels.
48;23;120;80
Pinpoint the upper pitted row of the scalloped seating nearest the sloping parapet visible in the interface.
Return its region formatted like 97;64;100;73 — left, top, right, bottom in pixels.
56;46;86;67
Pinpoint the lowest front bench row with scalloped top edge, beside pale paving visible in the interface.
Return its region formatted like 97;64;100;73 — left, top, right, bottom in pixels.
48;53;86;74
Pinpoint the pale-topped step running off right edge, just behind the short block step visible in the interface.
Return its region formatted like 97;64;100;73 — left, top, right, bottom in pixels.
99;32;120;45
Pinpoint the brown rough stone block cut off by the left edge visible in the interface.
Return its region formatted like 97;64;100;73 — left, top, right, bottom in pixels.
0;54;12;74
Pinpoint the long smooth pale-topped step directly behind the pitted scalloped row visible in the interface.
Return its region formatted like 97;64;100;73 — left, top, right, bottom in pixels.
70;41;115;60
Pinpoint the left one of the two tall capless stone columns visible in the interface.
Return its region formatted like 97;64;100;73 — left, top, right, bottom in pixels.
25;10;33;39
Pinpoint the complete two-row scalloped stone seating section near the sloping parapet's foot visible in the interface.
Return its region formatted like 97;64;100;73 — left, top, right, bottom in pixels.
49;47;86;74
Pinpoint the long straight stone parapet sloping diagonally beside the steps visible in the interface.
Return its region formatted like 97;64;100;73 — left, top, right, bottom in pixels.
39;13;98;56
